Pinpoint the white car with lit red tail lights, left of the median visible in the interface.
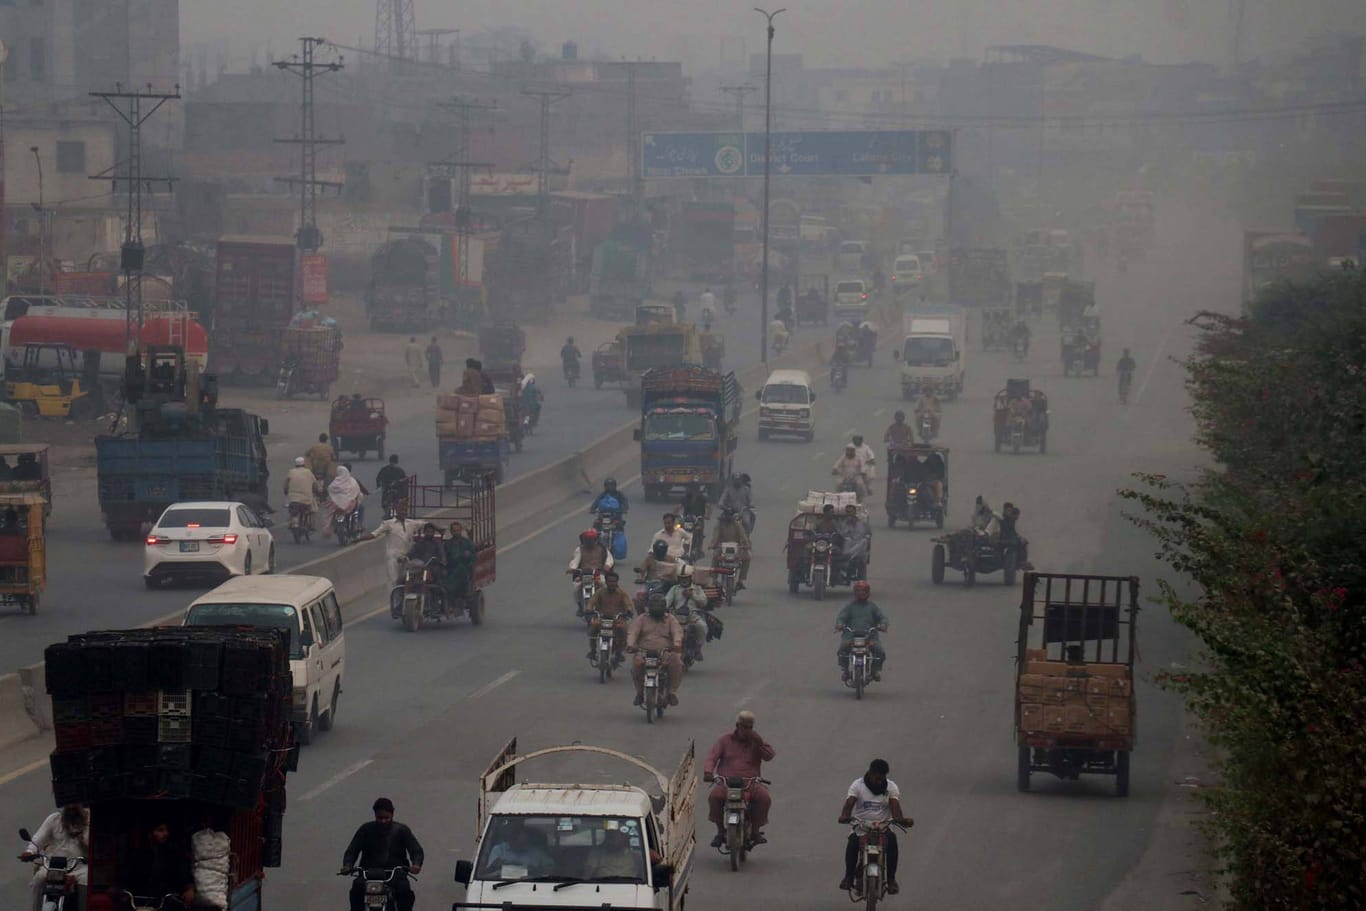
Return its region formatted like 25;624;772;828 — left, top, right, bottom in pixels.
142;501;275;589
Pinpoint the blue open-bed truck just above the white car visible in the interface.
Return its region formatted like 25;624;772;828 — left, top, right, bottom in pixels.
94;347;270;541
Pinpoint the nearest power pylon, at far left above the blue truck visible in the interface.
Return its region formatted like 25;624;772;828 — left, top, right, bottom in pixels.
90;82;180;350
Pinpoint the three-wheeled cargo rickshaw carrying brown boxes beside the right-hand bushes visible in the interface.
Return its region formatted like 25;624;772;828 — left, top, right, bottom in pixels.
1015;572;1138;798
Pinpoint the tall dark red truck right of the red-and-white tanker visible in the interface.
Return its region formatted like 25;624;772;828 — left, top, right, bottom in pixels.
209;235;299;385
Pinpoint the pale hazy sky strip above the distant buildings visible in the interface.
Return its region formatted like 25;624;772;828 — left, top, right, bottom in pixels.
180;0;1366;70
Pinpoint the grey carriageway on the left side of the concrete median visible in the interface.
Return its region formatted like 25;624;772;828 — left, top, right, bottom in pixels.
0;285;775;673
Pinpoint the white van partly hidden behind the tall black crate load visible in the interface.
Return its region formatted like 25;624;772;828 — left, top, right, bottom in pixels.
184;575;346;743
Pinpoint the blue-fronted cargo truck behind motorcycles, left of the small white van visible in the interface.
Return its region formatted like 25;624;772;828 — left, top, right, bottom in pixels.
635;365;740;501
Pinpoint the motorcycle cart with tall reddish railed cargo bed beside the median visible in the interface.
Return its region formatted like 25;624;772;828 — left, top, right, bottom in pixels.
389;474;497;632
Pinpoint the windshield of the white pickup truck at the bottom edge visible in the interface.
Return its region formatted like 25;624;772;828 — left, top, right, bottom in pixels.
475;815;646;884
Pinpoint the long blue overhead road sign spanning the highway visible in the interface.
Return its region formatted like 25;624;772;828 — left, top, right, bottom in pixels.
641;130;953;180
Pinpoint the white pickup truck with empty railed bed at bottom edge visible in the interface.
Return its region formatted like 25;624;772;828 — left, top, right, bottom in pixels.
451;739;697;911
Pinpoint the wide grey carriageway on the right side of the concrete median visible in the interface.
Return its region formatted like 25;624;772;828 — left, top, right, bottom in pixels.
0;203;1235;911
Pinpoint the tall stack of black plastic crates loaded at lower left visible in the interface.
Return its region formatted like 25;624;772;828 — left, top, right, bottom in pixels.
46;627;292;856
